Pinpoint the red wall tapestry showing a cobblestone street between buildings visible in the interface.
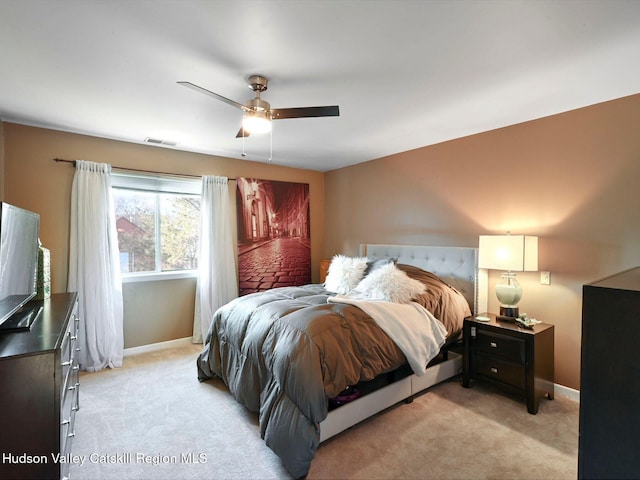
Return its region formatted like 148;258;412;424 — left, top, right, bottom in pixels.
236;177;311;296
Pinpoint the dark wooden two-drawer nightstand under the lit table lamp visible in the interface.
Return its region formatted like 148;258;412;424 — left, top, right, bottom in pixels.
462;313;554;415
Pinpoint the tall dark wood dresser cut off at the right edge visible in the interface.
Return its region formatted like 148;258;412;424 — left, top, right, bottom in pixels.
578;267;640;479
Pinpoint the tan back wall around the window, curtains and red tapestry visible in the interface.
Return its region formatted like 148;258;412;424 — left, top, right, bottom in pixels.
0;123;325;347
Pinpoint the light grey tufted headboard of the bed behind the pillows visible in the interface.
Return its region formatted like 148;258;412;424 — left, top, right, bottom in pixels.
360;244;488;314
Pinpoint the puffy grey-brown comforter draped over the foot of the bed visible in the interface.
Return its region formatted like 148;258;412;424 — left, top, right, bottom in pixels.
197;264;464;478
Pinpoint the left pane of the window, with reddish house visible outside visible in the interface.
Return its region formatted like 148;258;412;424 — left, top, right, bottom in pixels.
113;189;156;273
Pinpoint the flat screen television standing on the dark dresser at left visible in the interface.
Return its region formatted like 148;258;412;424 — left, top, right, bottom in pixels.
0;202;40;329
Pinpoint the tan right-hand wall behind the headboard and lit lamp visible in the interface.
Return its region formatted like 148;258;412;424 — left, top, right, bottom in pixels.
324;95;640;388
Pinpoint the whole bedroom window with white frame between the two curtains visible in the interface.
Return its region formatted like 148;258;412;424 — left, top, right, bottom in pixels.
111;173;201;279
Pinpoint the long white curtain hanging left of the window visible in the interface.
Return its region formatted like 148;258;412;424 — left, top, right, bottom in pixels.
67;160;124;372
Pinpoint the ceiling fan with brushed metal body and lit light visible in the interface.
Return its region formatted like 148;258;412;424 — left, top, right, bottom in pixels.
178;75;340;138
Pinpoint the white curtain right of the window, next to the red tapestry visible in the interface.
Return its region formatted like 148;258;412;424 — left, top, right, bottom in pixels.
193;176;238;343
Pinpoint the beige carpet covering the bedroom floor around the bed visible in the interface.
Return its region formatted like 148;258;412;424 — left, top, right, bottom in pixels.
71;345;578;480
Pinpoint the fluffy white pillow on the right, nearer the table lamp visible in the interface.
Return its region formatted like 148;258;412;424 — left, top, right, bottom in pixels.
356;263;427;303
